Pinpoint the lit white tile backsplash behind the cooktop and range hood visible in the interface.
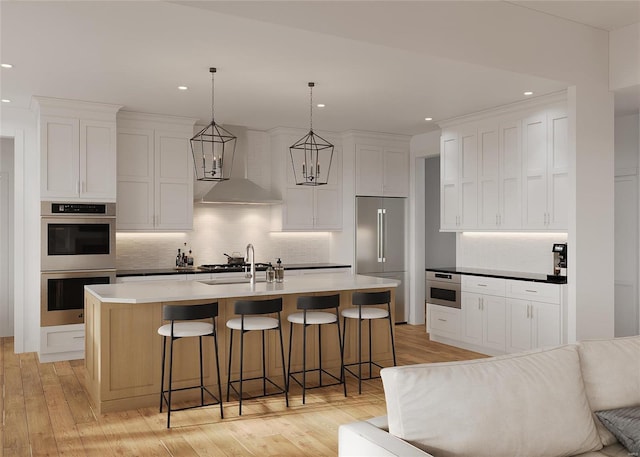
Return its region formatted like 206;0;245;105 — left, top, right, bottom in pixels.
116;205;330;270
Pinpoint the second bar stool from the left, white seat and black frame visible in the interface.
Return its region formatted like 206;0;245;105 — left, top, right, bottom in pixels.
227;298;289;416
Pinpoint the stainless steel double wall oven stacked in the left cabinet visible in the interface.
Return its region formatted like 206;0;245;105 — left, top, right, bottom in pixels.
40;202;116;326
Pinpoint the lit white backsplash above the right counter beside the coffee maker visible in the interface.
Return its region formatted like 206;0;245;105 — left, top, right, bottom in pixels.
456;232;571;274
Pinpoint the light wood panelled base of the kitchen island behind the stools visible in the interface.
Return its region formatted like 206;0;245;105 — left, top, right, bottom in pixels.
85;275;395;413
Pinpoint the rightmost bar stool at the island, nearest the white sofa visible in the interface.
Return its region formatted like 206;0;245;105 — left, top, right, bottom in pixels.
341;290;396;394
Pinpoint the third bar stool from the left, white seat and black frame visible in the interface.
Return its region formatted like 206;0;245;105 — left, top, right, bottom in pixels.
287;294;347;405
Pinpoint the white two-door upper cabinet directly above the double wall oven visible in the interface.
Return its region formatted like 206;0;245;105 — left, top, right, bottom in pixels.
34;97;121;202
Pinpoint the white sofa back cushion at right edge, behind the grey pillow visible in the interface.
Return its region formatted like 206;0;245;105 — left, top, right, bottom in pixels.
578;336;640;446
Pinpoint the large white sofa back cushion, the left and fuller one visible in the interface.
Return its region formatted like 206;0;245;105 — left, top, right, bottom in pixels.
381;346;602;457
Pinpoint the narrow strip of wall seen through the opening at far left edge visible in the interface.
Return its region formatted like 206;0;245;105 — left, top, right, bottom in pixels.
0;138;14;337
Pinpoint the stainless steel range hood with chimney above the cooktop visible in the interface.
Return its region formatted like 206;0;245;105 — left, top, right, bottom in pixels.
194;125;282;205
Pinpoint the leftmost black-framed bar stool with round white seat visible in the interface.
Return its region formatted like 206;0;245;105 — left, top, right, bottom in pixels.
158;303;224;428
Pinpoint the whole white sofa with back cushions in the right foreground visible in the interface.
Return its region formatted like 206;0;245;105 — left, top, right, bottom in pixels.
339;336;640;457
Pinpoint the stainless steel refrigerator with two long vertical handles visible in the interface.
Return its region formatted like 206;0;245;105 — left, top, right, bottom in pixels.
356;197;406;322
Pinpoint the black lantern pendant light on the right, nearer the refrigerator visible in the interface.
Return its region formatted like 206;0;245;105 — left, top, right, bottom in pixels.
289;82;333;186
